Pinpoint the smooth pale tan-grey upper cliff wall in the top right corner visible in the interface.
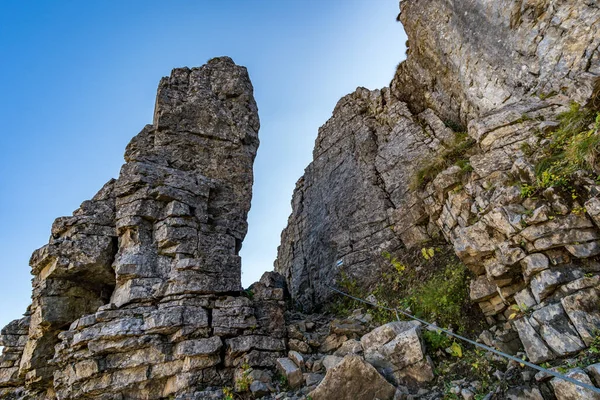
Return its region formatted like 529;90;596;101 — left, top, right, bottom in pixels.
391;0;600;123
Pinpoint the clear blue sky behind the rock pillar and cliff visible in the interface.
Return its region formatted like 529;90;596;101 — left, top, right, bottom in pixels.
0;0;406;327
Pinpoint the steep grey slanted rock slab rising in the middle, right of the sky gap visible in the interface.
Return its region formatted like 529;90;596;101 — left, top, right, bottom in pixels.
275;89;453;309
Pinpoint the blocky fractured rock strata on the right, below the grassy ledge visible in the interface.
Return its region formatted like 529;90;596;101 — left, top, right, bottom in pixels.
420;96;600;363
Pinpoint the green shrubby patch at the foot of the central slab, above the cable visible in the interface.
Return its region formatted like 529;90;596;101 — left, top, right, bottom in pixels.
329;246;481;333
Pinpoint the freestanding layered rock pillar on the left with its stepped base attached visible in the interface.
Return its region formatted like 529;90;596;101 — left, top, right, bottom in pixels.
0;57;285;399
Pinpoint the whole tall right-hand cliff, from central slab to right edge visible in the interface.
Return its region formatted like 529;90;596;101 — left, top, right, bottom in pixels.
275;0;600;396
